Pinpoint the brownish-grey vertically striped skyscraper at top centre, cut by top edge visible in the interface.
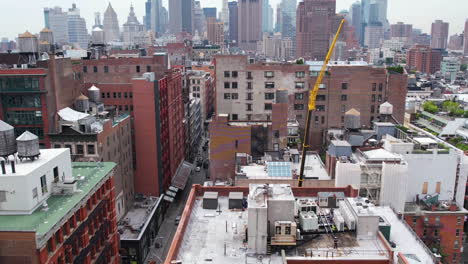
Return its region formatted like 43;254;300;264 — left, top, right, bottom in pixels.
238;0;263;51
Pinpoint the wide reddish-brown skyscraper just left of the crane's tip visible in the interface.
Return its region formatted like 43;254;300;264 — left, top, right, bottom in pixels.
296;0;337;60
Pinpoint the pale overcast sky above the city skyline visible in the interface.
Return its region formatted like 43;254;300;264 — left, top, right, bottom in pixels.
0;0;468;39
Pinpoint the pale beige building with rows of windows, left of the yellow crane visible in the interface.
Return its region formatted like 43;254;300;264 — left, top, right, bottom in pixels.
215;55;310;124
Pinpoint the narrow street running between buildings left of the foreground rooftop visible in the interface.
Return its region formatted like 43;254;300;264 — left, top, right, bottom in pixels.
145;135;208;264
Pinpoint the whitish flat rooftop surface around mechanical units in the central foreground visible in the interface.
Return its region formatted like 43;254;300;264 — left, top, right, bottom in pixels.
177;196;434;264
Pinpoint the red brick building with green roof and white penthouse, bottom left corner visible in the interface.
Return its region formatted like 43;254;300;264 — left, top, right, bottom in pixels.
0;149;120;264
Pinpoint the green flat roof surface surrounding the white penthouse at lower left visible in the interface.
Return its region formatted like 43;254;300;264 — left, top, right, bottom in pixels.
0;162;115;239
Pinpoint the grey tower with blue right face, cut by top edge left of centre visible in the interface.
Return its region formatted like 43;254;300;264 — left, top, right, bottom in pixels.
169;0;194;33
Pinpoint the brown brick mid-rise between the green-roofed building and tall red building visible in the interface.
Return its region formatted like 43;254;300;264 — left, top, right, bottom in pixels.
50;106;135;219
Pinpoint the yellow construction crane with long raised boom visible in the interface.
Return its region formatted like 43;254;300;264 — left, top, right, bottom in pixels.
299;19;346;187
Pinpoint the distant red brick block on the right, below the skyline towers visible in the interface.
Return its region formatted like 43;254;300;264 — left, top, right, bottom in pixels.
406;45;442;74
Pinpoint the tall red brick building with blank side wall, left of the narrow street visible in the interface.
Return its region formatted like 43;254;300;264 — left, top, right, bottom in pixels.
132;72;185;196
